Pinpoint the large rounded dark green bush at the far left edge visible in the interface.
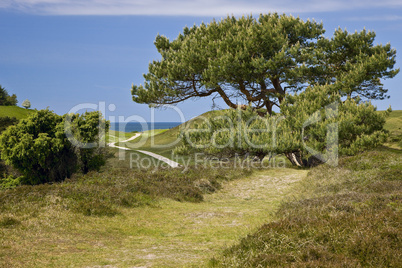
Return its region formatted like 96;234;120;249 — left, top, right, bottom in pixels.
0;110;76;184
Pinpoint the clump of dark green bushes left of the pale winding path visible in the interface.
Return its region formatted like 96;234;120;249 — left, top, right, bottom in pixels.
0;110;108;184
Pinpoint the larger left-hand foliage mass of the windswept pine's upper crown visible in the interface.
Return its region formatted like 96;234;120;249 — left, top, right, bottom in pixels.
132;14;324;111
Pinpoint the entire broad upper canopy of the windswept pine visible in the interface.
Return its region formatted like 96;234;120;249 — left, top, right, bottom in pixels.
131;13;399;114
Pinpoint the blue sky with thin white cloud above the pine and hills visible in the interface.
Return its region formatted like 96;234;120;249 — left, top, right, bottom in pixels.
0;0;402;121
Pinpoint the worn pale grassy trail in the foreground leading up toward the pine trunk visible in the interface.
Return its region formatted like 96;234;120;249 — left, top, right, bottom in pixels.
102;169;307;267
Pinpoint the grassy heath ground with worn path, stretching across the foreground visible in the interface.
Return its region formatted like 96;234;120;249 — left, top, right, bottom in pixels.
0;111;402;267
